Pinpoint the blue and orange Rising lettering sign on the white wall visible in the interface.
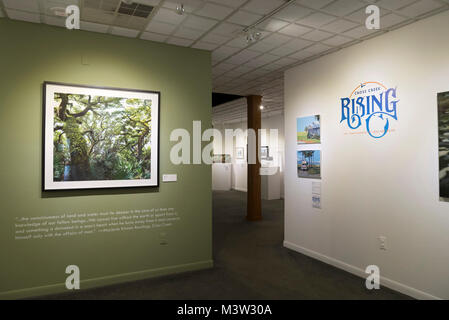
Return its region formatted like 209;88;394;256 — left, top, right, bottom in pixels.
340;81;399;139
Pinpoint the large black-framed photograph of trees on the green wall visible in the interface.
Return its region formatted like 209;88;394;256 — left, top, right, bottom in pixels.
43;82;160;190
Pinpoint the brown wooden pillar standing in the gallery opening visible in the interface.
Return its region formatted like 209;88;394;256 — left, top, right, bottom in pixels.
246;96;262;221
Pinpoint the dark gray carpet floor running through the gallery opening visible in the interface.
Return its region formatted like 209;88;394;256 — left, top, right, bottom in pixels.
39;191;409;300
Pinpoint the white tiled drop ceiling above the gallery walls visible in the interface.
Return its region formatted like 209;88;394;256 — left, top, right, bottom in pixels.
0;0;449;118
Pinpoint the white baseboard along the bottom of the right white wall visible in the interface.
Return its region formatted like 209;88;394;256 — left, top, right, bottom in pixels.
284;241;441;300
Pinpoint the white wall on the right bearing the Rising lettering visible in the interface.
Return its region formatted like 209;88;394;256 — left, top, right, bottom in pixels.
284;11;449;299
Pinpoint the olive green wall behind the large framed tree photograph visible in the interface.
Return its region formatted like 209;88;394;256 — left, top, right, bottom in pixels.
0;19;212;298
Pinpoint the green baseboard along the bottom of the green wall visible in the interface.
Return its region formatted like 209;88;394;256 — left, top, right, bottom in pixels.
0;260;213;299
